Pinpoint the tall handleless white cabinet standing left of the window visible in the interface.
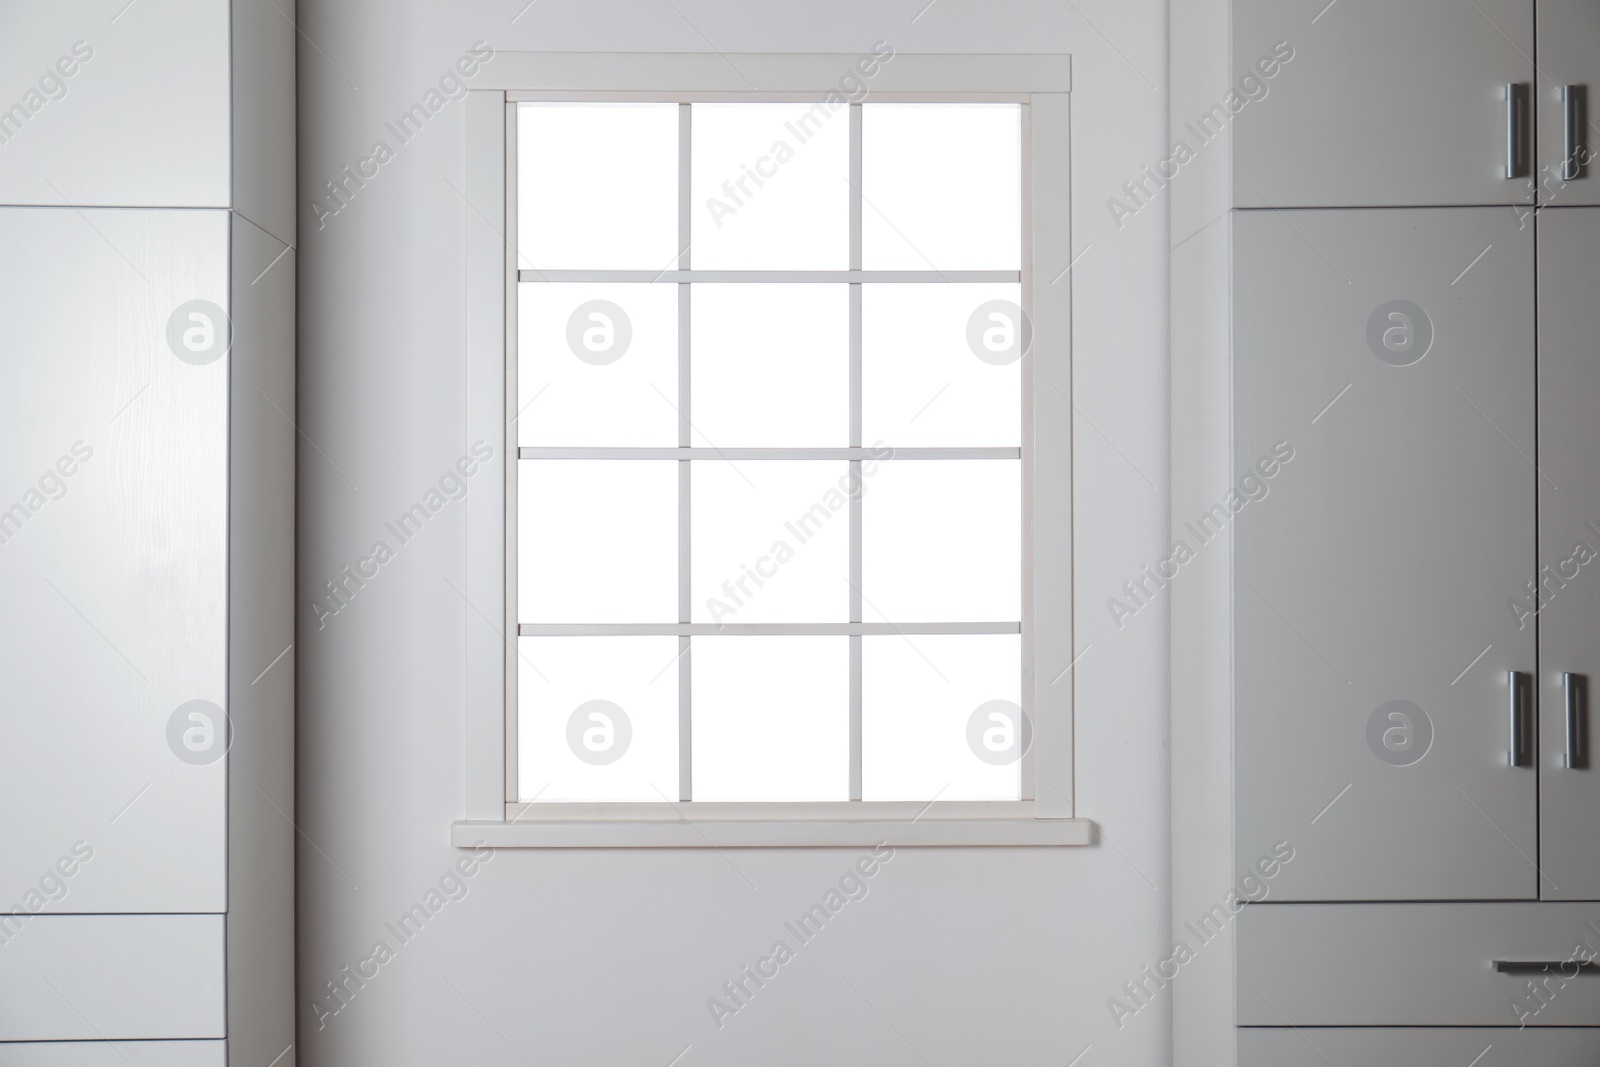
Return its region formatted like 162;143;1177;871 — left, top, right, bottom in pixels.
0;0;296;1067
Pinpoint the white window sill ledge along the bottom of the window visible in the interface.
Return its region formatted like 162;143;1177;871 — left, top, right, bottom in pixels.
450;801;1094;848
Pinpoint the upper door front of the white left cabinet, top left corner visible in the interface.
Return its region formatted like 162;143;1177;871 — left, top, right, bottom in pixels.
0;0;228;208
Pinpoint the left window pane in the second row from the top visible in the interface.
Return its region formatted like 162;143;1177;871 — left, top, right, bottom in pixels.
517;282;678;448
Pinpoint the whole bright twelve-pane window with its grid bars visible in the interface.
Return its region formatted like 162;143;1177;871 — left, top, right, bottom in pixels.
464;53;1085;845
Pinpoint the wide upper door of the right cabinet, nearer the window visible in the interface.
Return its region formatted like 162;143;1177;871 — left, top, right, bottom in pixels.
1235;0;1534;208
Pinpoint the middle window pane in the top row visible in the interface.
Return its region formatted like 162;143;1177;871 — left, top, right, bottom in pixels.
690;104;850;270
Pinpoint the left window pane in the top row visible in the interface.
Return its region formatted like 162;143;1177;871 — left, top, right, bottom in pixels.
517;104;678;270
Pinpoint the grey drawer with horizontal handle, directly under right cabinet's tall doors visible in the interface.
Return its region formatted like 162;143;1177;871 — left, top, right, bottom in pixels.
1238;902;1600;1027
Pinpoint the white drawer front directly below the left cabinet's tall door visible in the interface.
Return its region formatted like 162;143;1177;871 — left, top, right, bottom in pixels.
0;915;226;1036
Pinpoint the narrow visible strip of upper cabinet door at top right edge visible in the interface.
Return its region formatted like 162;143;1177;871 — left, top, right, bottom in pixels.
1533;0;1600;205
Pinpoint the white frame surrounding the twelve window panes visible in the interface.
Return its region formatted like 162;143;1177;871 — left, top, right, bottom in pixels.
451;53;1094;848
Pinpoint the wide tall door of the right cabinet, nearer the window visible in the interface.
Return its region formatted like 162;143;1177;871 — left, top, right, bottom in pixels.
1235;208;1538;901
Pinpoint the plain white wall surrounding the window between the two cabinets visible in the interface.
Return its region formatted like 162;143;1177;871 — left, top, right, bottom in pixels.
296;0;1171;1067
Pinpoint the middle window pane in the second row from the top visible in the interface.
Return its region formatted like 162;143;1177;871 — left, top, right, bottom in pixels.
690;283;850;448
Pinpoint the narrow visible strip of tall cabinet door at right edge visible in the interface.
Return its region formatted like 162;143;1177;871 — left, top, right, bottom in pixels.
1536;208;1600;901
